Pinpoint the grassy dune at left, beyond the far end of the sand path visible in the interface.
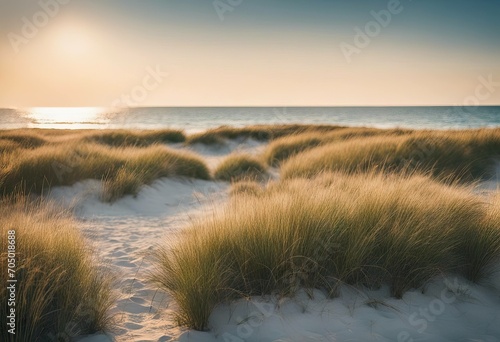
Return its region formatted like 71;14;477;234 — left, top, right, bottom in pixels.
0;129;203;201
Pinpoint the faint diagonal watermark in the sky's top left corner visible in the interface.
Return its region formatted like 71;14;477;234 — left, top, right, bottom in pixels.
7;0;70;53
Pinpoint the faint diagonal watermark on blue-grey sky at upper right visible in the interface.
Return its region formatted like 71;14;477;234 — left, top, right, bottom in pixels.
339;0;411;63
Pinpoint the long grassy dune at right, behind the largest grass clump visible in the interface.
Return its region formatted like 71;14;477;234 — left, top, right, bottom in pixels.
281;129;500;181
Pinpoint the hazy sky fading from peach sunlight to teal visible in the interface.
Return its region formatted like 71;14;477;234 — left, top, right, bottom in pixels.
0;0;500;108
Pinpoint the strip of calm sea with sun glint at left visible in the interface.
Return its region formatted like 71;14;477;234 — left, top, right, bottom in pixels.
0;106;500;132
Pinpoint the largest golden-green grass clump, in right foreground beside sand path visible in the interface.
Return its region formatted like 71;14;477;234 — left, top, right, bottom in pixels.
152;173;500;330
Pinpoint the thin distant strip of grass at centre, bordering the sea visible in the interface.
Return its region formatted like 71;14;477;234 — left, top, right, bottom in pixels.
186;124;339;145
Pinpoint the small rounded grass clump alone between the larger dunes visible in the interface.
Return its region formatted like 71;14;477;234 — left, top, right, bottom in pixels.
214;154;266;181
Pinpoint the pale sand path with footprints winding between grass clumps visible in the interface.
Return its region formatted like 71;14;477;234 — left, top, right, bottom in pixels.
51;179;227;342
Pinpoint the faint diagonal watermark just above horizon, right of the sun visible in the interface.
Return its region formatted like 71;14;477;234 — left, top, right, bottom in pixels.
111;65;169;108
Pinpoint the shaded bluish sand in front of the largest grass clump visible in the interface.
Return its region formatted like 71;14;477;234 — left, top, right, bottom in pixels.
187;278;500;342
